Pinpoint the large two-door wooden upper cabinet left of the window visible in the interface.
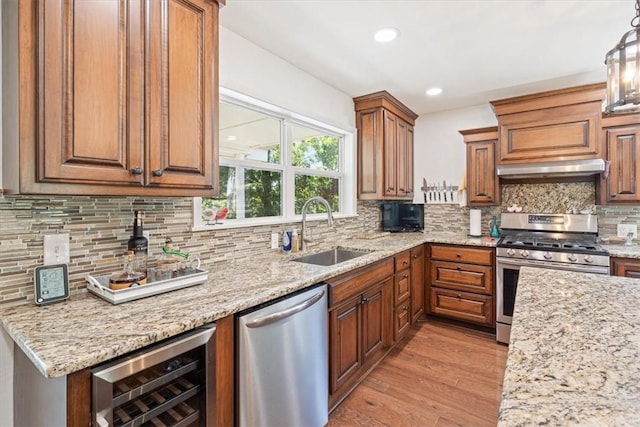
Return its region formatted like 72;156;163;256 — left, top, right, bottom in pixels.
3;0;219;196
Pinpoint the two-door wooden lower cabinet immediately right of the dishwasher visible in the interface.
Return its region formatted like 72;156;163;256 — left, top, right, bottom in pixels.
327;258;394;409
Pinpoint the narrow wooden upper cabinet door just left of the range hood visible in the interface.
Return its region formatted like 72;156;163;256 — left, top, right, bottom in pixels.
467;141;499;206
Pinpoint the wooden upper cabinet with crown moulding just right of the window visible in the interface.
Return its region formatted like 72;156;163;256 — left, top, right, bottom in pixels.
353;91;418;200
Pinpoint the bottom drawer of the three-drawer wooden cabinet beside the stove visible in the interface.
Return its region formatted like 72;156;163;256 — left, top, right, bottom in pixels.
429;288;494;326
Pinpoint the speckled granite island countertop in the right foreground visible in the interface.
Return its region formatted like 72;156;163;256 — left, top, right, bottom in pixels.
498;267;640;427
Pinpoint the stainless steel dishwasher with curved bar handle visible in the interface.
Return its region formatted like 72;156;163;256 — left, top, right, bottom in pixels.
237;283;329;427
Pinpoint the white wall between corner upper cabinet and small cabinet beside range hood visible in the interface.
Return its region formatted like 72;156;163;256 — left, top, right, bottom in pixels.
413;103;498;203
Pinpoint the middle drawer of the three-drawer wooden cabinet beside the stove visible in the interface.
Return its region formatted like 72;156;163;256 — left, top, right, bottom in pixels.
429;261;493;295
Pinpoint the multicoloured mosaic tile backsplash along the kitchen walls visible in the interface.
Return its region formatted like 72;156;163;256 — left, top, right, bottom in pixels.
0;183;640;305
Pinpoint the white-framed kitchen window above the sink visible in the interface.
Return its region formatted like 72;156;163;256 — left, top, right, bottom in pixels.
194;88;356;229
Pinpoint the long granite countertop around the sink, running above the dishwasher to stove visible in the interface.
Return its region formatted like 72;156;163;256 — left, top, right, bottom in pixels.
0;233;496;377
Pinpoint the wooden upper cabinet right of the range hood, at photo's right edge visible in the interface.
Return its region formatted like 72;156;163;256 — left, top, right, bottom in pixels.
599;114;640;204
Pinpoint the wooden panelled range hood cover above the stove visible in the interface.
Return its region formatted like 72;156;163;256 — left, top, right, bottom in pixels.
491;83;606;165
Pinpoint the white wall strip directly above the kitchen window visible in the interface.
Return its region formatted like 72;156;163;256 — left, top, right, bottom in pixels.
219;26;355;130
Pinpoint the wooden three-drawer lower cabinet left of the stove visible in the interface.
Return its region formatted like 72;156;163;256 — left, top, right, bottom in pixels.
427;244;495;328
